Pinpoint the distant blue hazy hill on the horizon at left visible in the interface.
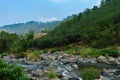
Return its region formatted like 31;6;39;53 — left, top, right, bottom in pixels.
0;21;61;35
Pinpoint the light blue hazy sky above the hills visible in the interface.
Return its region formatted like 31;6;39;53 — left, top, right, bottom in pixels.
0;0;101;26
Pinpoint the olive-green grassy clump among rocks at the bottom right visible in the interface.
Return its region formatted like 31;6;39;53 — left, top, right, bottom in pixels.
80;67;101;80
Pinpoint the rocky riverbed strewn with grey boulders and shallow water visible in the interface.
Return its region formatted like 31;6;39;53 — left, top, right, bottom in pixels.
0;52;120;80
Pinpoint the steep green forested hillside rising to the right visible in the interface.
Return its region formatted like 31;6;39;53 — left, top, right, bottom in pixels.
34;0;120;48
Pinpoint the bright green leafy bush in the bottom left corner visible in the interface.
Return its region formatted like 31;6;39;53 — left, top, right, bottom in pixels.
0;60;29;80
